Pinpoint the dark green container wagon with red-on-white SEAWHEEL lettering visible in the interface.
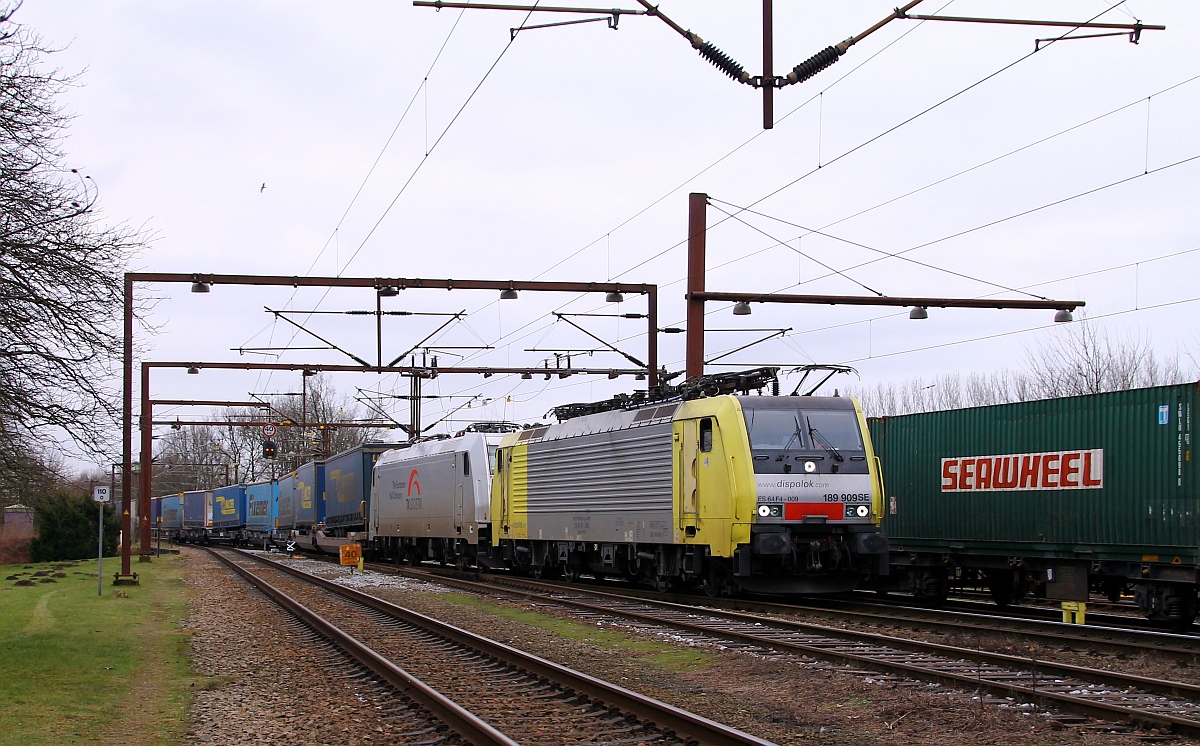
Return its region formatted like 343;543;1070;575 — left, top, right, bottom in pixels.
870;384;1200;625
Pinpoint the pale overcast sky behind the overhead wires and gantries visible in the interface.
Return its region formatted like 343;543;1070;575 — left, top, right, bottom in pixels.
17;0;1200;458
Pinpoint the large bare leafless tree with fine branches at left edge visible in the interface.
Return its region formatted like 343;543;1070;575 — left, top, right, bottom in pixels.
0;7;143;498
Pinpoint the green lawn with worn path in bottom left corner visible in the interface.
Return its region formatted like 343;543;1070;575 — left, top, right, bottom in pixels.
0;557;196;746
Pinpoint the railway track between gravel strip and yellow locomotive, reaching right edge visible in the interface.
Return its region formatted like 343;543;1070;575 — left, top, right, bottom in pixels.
328;566;1200;738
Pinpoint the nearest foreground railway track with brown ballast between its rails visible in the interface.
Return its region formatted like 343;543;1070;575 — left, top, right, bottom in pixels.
212;549;768;746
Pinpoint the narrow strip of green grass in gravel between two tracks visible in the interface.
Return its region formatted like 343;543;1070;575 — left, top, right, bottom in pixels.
434;594;716;673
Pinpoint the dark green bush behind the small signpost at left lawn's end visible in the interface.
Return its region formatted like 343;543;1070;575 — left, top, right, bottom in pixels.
29;491;121;562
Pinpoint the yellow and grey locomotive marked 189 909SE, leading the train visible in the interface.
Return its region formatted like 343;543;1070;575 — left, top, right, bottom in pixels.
481;371;888;595
